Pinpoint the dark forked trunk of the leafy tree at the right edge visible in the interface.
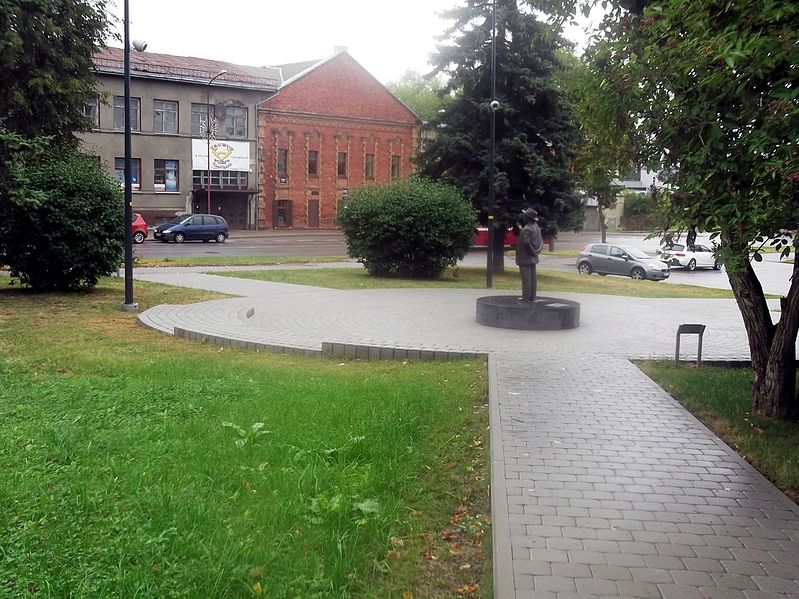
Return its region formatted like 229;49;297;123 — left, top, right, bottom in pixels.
727;250;799;419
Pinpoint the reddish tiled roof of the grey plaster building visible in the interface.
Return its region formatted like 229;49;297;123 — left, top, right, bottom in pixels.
94;47;282;91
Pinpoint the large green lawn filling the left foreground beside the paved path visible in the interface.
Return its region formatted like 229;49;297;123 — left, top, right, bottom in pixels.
0;277;492;599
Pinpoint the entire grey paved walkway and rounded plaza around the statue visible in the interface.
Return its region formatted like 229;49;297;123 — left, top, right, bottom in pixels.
136;269;799;599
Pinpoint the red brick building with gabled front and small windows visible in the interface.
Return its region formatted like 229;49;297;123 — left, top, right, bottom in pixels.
258;51;421;229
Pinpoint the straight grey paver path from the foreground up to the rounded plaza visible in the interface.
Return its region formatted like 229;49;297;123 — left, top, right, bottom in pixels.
491;354;799;598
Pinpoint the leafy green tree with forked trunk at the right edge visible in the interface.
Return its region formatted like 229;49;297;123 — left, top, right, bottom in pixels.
593;0;799;418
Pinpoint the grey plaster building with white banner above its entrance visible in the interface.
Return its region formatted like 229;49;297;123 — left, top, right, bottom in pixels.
82;48;282;229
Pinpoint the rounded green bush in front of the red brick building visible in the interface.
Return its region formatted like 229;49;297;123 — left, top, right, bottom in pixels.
338;178;476;279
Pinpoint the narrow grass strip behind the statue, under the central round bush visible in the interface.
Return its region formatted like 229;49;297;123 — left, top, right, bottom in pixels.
213;266;733;299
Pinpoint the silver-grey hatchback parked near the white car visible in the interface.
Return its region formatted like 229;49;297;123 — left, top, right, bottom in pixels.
577;243;670;281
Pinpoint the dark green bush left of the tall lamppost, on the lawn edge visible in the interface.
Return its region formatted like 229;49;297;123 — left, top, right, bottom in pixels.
0;154;124;291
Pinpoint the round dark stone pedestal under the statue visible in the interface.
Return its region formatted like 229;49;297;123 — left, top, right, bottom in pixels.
477;295;580;331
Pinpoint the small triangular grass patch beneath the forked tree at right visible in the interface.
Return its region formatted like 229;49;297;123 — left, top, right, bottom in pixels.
638;361;799;503
